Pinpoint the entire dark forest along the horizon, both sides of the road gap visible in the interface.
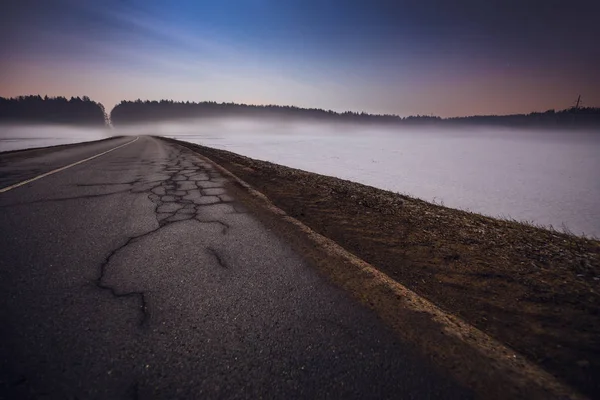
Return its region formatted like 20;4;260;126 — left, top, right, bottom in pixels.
0;95;600;129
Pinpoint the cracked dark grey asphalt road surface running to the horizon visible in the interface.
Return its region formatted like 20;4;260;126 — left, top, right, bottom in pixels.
0;137;471;399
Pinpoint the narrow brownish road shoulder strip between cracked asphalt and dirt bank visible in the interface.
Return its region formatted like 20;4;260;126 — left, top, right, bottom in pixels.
164;137;583;398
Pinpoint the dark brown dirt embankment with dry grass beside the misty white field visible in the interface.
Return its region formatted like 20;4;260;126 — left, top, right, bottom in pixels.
162;137;600;397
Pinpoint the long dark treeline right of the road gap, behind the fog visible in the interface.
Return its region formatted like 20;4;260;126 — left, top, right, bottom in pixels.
111;100;600;128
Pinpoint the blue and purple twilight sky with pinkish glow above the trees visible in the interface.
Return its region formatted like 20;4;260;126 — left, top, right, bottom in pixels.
0;0;600;117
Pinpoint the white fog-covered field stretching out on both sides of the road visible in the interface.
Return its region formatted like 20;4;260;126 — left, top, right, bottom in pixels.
0;120;600;237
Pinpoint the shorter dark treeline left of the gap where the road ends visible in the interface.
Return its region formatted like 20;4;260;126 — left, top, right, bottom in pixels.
0;96;106;126
